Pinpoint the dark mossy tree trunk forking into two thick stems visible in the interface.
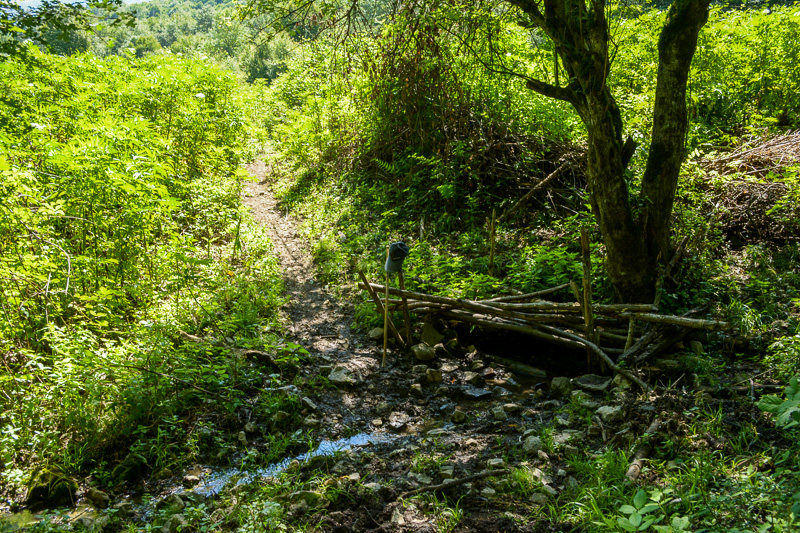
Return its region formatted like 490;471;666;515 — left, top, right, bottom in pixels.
509;0;709;303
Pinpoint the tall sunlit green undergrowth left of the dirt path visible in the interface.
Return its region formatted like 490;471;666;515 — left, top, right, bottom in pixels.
0;49;288;496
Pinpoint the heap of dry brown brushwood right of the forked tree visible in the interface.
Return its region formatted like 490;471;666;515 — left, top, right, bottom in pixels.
701;131;800;245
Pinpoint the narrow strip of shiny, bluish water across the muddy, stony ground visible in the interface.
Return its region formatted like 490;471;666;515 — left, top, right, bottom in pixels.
192;433;396;497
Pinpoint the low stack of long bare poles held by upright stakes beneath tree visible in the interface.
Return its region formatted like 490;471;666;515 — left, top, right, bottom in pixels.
360;234;727;390
